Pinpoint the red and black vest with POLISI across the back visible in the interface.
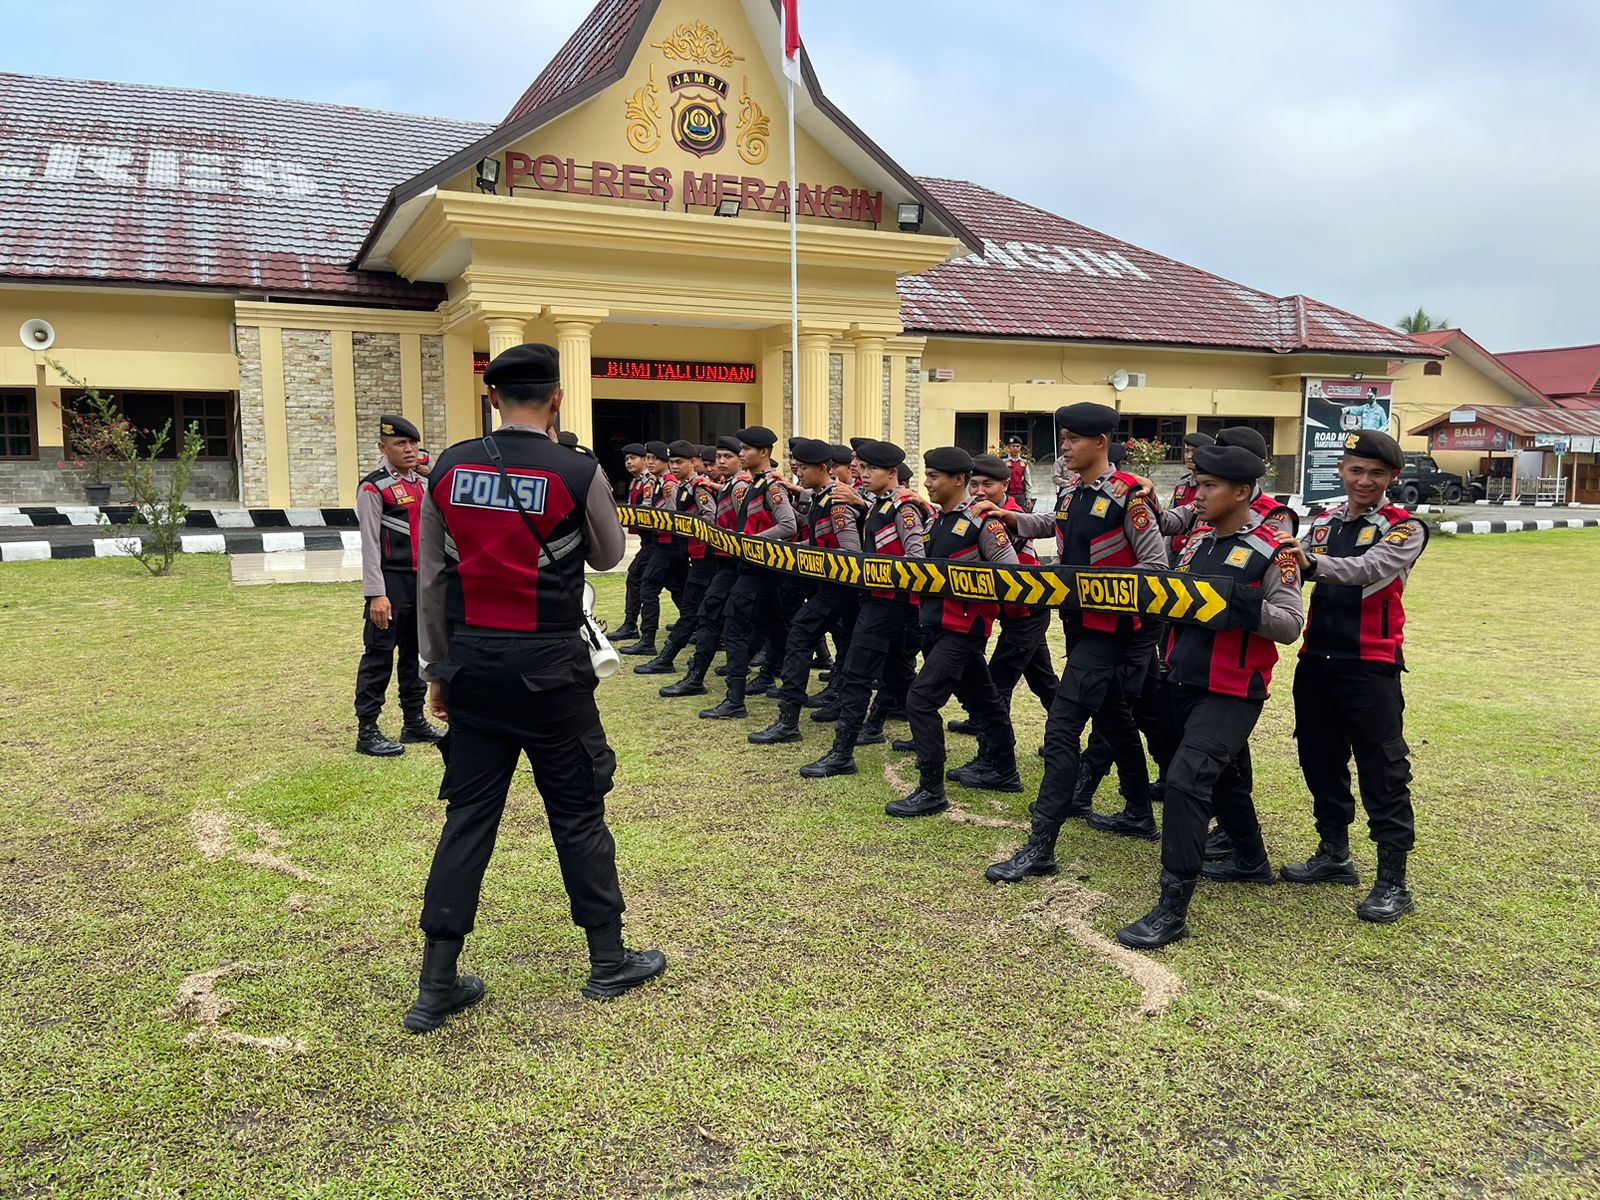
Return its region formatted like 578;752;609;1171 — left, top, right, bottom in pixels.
427;430;595;634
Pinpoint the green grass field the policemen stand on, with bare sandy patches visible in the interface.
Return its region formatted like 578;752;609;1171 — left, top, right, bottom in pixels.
0;531;1600;1200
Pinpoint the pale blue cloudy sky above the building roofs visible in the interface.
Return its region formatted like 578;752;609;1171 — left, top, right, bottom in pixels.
12;0;1600;350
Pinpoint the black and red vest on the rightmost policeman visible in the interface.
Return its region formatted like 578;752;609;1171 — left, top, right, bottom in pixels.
1301;504;1427;667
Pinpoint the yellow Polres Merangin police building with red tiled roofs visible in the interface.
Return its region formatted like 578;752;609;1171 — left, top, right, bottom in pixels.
0;0;1446;507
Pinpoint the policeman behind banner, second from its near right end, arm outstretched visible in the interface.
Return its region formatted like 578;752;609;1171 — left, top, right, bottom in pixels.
974;403;1166;883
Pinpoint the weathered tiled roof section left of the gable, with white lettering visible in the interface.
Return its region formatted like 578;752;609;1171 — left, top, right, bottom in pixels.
0;74;488;306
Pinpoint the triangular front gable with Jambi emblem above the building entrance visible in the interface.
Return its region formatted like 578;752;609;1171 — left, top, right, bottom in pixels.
355;0;978;269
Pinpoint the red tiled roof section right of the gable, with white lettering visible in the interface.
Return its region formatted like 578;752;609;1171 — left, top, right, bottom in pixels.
901;179;1443;358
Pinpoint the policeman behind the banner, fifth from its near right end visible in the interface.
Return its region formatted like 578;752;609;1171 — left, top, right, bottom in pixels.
749;437;861;746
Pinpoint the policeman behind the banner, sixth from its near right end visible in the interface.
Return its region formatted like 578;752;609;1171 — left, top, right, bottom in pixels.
694;426;798;720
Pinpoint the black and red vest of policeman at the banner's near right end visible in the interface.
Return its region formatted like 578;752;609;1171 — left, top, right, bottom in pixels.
1166;525;1280;699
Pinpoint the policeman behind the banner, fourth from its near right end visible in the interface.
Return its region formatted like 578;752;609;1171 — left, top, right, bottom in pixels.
800;438;926;779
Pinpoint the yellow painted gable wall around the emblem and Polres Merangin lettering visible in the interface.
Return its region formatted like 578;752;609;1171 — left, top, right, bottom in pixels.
445;0;870;227
